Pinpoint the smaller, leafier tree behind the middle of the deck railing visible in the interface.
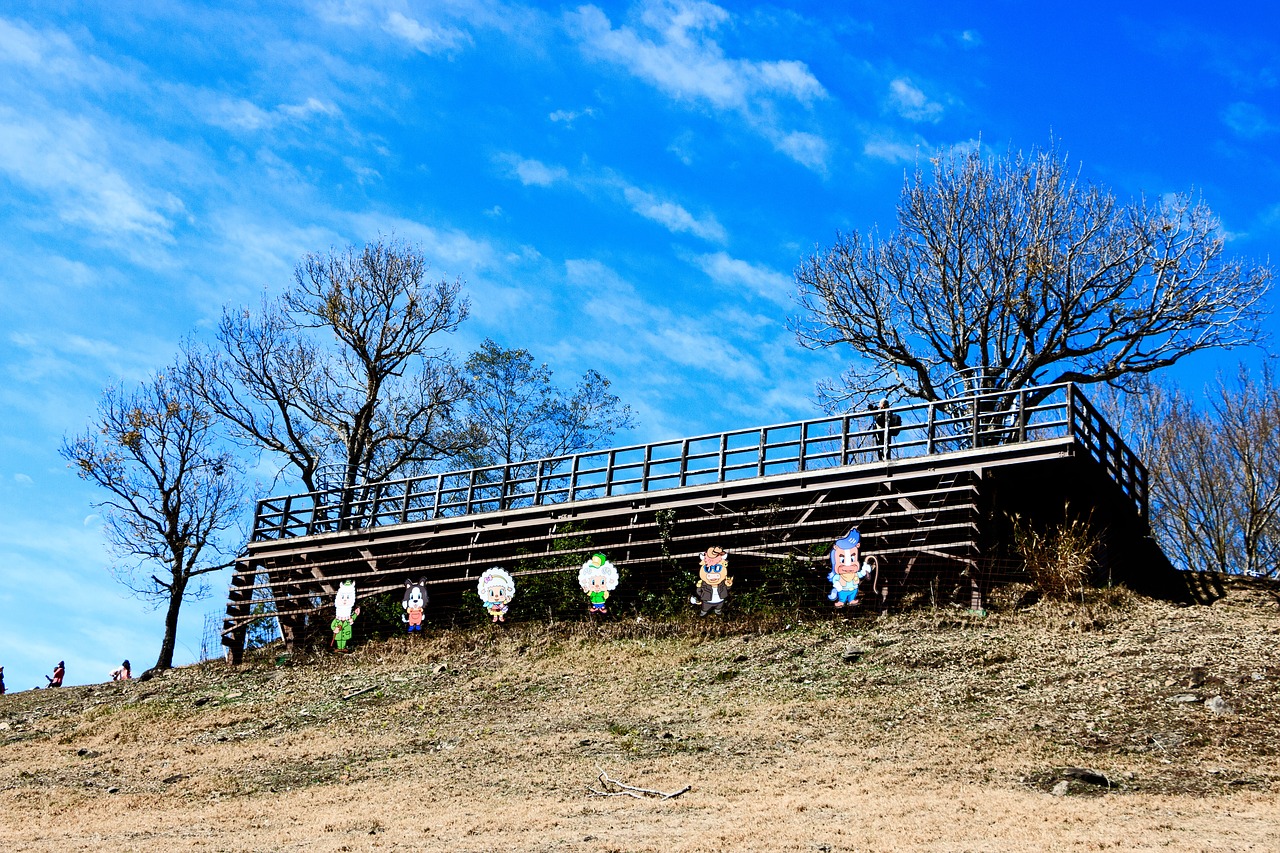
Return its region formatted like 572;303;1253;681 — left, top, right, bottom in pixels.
466;339;634;465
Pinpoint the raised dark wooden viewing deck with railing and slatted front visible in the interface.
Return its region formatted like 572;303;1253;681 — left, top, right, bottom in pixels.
223;384;1148;658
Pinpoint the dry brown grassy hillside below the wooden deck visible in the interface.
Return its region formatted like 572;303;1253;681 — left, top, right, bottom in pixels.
0;584;1280;852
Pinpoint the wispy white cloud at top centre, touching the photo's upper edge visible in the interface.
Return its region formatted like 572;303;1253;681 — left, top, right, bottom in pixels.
567;1;827;170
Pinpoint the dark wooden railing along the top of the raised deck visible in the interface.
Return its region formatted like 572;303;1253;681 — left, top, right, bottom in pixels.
253;383;1147;542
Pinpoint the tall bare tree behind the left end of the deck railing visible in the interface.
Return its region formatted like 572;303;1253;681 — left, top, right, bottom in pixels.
188;240;475;491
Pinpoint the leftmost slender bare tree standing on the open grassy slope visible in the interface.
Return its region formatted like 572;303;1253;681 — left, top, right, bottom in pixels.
60;368;243;669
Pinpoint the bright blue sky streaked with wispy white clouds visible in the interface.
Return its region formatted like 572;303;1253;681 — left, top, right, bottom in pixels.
0;0;1280;690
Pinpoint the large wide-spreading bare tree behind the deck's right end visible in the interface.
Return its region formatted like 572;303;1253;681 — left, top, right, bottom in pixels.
792;145;1271;407
